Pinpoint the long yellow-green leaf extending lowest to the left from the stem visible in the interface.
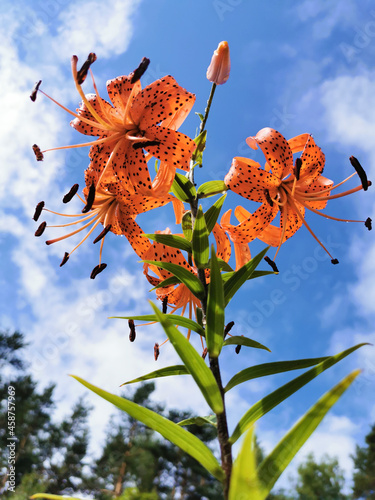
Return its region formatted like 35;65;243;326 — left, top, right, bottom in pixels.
73;376;224;481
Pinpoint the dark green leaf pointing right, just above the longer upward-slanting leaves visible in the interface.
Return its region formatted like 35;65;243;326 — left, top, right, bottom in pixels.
224;356;328;392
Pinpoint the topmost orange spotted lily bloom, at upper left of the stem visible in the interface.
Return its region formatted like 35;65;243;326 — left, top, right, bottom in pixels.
30;54;195;197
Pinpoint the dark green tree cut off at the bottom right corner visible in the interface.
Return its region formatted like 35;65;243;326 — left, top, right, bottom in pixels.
352;424;375;500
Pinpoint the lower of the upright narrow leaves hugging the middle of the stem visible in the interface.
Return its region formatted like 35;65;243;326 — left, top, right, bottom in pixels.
206;245;225;358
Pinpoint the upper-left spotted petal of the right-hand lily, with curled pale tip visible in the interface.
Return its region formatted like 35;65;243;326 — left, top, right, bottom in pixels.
246;127;293;179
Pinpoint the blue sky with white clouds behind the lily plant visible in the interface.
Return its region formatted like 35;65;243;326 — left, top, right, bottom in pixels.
0;0;375;492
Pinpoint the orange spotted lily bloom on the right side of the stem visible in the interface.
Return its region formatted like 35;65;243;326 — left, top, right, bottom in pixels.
222;128;371;264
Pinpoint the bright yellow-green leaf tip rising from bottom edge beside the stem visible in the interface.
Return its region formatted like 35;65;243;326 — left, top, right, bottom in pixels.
229;427;265;500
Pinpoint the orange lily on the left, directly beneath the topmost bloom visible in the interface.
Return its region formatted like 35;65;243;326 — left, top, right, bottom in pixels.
34;163;183;278
